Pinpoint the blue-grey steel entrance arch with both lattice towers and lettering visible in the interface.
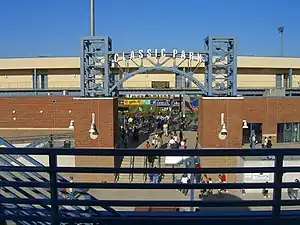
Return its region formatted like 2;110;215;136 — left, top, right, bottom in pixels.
80;37;237;97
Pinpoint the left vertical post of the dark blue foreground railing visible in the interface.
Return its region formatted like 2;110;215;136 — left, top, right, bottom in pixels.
49;150;59;225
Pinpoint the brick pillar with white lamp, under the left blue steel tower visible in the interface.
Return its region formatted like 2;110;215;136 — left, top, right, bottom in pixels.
74;98;118;182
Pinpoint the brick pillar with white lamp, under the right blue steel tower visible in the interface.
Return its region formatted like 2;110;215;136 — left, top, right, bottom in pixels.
199;97;243;182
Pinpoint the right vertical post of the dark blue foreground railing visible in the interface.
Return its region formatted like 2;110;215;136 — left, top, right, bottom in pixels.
272;153;284;220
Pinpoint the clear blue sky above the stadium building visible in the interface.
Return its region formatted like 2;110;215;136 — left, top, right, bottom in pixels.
0;0;300;57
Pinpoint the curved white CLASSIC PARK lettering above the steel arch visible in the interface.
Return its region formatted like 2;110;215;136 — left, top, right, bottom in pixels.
113;48;203;62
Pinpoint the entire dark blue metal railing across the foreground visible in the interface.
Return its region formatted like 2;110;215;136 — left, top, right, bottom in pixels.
0;148;300;225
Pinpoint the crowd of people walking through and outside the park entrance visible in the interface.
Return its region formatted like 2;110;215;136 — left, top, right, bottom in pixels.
121;114;299;199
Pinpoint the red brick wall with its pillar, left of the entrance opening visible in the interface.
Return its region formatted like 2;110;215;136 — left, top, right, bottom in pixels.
0;96;118;181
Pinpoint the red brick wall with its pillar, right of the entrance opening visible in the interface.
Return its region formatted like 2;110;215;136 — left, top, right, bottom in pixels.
198;97;300;181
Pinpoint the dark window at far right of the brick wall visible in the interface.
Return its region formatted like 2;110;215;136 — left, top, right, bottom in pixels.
277;122;300;143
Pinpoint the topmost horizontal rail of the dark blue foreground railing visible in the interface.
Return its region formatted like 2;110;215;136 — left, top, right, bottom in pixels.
0;148;300;156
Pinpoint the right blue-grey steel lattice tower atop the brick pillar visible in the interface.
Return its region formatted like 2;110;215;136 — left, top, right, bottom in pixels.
204;37;237;96
